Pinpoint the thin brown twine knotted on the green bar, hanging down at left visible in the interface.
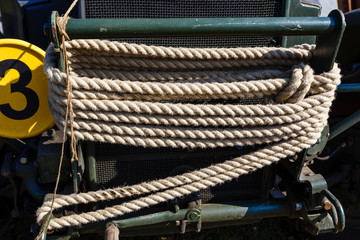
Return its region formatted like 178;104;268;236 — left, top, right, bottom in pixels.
35;0;78;240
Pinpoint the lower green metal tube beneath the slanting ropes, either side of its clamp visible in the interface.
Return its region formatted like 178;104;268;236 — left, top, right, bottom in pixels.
109;199;292;229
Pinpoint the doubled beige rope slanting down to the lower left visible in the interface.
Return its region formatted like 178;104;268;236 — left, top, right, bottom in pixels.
37;135;320;229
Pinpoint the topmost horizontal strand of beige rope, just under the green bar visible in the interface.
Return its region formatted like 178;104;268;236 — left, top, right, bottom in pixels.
65;39;314;60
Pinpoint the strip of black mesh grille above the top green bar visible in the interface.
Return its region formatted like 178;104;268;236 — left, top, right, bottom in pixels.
85;0;282;18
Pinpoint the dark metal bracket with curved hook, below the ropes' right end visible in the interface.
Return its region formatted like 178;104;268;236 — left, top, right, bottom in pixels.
280;136;345;235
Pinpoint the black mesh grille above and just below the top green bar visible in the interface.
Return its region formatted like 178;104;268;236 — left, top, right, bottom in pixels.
85;0;284;47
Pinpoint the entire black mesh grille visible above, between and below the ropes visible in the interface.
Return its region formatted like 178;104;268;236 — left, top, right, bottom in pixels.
85;0;285;202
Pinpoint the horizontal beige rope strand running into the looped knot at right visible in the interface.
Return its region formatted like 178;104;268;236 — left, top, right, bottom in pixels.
50;71;289;99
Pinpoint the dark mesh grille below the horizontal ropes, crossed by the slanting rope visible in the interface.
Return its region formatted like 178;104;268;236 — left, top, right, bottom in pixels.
95;143;261;202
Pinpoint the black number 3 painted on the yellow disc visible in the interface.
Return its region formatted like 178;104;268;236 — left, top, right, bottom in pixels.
0;59;39;120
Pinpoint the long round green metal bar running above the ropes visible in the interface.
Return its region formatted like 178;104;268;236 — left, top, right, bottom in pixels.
66;17;336;38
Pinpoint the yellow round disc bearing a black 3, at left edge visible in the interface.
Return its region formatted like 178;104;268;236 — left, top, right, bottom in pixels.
0;39;54;138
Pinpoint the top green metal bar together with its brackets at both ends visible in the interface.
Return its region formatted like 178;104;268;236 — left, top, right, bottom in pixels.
44;10;346;73
